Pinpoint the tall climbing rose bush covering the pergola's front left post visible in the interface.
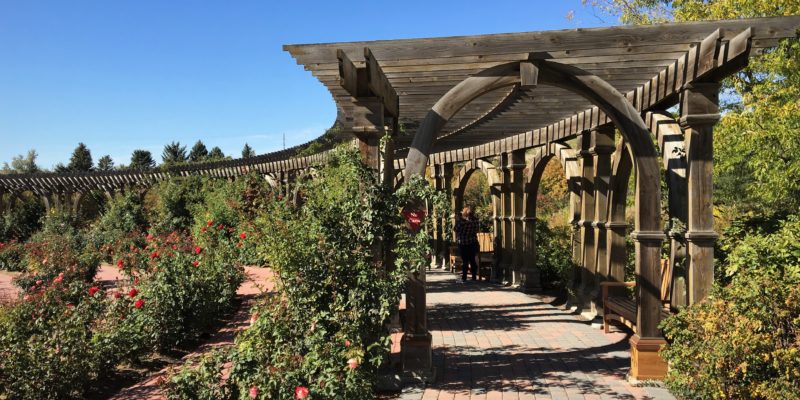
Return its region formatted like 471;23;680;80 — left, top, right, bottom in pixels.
165;151;438;399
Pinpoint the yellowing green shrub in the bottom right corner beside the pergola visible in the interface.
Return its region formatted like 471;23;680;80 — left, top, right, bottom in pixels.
663;217;800;399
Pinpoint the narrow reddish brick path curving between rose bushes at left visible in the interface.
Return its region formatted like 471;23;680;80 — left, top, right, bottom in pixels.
104;267;274;400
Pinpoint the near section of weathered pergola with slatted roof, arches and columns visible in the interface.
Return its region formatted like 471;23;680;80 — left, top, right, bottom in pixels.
284;16;800;379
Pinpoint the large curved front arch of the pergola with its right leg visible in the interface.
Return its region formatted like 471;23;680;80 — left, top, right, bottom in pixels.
405;60;664;338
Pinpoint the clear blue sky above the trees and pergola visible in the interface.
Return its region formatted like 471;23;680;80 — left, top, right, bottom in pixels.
0;0;614;168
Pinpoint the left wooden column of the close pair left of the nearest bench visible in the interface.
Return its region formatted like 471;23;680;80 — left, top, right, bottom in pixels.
577;131;595;311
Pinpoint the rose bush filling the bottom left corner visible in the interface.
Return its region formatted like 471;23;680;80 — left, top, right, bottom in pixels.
0;277;138;399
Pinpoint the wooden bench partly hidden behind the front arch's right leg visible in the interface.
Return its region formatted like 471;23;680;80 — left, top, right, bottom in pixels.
600;259;672;333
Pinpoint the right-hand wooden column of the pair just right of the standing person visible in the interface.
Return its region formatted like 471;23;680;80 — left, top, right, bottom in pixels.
506;150;525;286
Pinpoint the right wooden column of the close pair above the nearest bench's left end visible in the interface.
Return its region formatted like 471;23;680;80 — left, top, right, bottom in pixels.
589;124;615;315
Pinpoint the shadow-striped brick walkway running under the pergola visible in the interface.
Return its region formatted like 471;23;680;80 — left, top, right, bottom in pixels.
399;270;673;400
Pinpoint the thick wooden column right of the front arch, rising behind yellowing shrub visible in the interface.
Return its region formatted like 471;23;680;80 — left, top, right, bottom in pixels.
680;83;720;305
